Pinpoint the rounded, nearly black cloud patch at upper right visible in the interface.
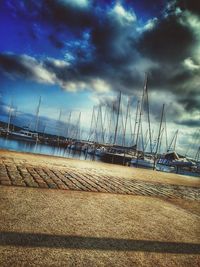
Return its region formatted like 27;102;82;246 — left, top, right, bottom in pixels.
138;16;195;63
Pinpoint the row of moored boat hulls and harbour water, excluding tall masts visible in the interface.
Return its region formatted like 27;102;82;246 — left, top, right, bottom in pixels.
0;136;200;177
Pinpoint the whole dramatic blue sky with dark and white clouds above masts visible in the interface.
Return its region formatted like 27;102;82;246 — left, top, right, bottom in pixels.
0;0;200;157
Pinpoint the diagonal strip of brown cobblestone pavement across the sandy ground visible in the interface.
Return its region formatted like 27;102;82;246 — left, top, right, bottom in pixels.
0;157;200;200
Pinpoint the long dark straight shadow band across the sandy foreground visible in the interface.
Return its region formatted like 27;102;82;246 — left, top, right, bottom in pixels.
0;232;200;254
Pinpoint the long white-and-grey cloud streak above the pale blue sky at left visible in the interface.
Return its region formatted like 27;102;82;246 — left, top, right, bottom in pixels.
0;54;112;93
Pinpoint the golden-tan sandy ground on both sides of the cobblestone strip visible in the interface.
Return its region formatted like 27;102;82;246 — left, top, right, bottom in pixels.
0;151;200;267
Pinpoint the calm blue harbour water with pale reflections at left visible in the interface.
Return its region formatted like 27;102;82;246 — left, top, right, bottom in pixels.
0;137;99;160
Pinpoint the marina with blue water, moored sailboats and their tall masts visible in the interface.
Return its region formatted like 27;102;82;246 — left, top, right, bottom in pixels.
0;74;200;177
